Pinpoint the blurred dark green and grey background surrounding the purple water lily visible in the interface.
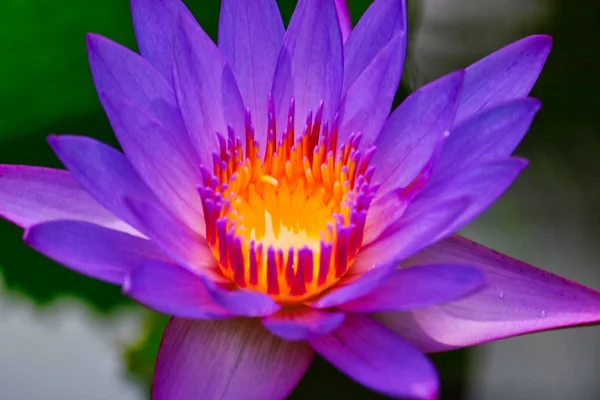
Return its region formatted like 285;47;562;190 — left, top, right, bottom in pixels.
0;0;600;400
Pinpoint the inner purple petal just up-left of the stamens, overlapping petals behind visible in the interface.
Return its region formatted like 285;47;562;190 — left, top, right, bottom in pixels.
173;12;245;165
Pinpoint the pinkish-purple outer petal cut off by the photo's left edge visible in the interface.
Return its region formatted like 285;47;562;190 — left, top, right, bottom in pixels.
0;165;135;236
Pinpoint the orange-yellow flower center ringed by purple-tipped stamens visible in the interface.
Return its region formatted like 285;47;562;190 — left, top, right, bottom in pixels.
200;100;375;303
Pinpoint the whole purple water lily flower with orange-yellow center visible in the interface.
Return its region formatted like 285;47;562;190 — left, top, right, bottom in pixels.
0;0;600;400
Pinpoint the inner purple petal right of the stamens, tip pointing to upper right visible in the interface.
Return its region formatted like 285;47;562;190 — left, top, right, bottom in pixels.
373;71;464;193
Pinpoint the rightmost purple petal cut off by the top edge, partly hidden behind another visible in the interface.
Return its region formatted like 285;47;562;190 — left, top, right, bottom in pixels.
342;0;407;94
